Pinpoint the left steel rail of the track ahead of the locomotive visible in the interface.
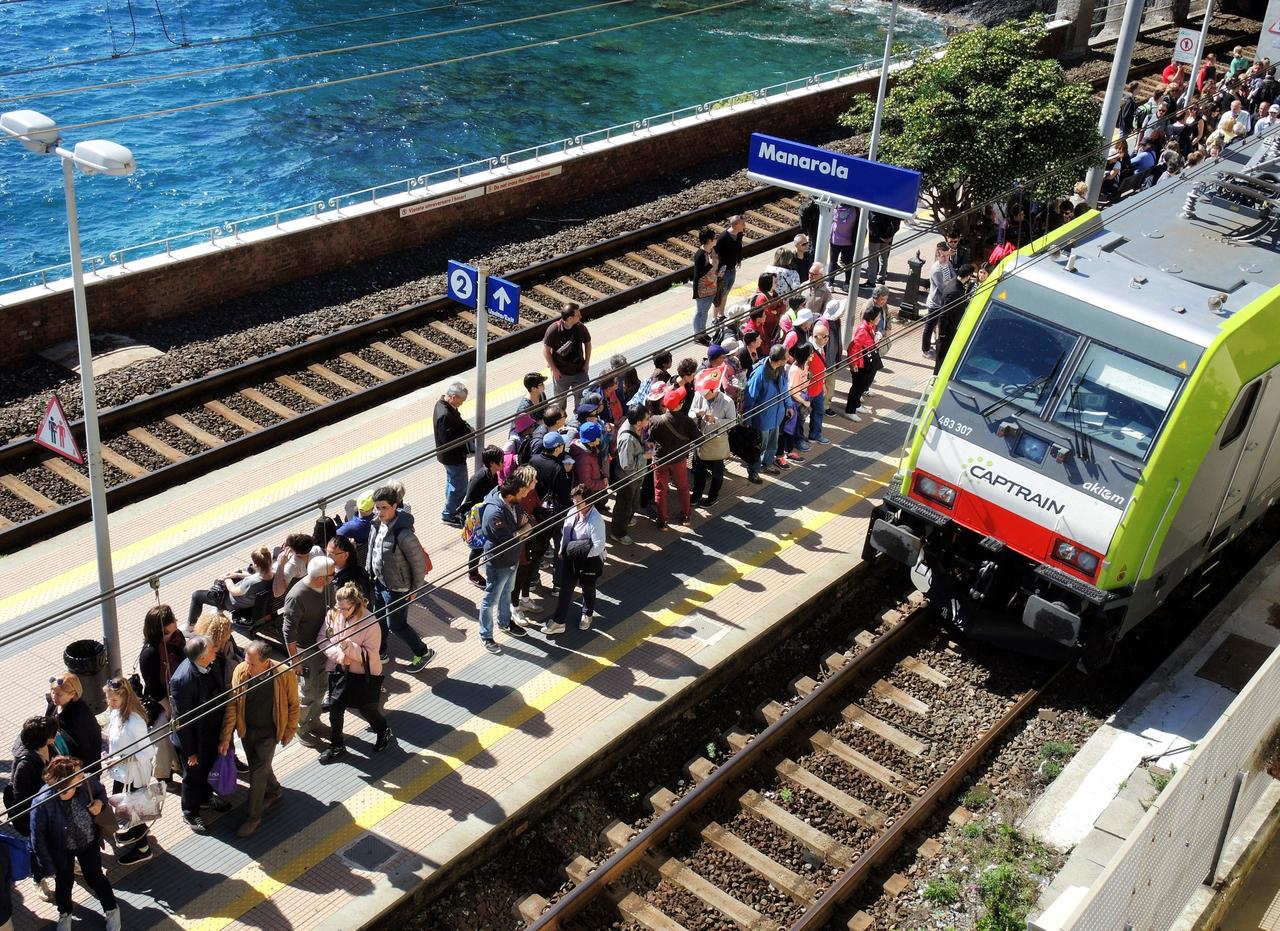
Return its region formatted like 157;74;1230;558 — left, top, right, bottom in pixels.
526;608;928;931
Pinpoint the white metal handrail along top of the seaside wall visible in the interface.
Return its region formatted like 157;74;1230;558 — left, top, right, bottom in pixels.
0;42;945;296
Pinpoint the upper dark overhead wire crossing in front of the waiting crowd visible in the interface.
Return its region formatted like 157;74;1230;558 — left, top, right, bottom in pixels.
0;99;1185;647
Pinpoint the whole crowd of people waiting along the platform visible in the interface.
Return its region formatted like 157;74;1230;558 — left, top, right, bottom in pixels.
12;40;1249;931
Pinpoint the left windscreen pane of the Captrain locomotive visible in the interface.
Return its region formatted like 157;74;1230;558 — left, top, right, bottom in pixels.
955;304;1078;412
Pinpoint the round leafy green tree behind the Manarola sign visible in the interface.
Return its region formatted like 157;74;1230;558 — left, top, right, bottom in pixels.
840;15;1102;233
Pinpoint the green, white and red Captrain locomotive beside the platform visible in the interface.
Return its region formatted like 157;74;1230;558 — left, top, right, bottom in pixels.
864;132;1280;670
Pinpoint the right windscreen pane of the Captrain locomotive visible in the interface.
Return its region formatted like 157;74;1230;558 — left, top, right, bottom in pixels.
1053;343;1183;460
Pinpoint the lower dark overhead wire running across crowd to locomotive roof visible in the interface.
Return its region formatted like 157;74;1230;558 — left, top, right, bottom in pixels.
0;167;1203;826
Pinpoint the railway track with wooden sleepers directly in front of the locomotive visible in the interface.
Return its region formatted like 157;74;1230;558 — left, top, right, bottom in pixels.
516;602;1061;931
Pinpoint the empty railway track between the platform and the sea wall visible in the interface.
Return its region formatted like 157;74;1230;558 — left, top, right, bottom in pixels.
0;188;799;552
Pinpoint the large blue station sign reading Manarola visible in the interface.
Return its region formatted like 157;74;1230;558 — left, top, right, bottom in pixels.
746;133;920;219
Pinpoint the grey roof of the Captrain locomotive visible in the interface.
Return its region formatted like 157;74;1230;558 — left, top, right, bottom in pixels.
1006;131;1280;347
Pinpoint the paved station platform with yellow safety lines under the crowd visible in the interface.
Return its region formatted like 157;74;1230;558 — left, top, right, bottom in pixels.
0;234;937;931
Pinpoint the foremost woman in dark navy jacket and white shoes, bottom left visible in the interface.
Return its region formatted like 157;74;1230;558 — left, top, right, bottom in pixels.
31;757;120;931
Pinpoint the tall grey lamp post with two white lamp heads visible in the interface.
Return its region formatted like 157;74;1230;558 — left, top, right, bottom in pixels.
0;110;137;676
